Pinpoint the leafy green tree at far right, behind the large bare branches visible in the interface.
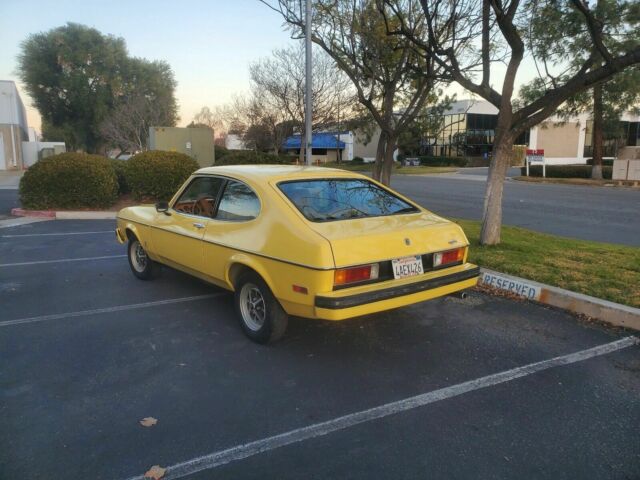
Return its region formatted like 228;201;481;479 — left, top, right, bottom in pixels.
520;0;640;179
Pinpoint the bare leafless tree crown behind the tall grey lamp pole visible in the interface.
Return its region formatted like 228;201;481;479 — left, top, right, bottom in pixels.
249;42;353;160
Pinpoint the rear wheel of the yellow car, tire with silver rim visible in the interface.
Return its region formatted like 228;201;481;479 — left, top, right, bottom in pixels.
234;272;289;344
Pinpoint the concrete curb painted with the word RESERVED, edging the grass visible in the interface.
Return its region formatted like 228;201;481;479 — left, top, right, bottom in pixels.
479;268;640;331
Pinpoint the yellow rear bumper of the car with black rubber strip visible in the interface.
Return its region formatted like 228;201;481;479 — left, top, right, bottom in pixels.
314;263;480;320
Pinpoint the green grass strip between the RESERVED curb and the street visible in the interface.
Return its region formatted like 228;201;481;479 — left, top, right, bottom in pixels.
456;220;640;308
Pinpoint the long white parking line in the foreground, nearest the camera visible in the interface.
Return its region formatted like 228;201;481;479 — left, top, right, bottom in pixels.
122;336;640;480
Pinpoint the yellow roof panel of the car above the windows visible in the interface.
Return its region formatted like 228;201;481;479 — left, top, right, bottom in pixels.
195;165;366;182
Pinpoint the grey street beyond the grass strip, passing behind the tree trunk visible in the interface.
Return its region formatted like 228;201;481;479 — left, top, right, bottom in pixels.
391;169;640;247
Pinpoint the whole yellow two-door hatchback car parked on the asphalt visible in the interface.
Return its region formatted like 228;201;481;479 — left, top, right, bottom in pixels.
116;165;479;343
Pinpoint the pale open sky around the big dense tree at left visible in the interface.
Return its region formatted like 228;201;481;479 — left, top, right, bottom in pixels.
0;0;291;131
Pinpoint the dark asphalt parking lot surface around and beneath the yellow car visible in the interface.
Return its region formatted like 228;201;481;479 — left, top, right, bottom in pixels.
0;221;640;480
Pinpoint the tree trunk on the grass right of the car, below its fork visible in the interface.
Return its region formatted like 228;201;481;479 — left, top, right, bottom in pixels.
480;134;514;245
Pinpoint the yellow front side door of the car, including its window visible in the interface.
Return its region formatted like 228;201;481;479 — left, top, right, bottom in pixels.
152;176;225;276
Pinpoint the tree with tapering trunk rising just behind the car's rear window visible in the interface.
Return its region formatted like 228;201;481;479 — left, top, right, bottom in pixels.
262;0;438;184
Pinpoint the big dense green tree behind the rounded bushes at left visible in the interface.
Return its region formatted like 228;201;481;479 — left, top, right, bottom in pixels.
18;23;177;152
